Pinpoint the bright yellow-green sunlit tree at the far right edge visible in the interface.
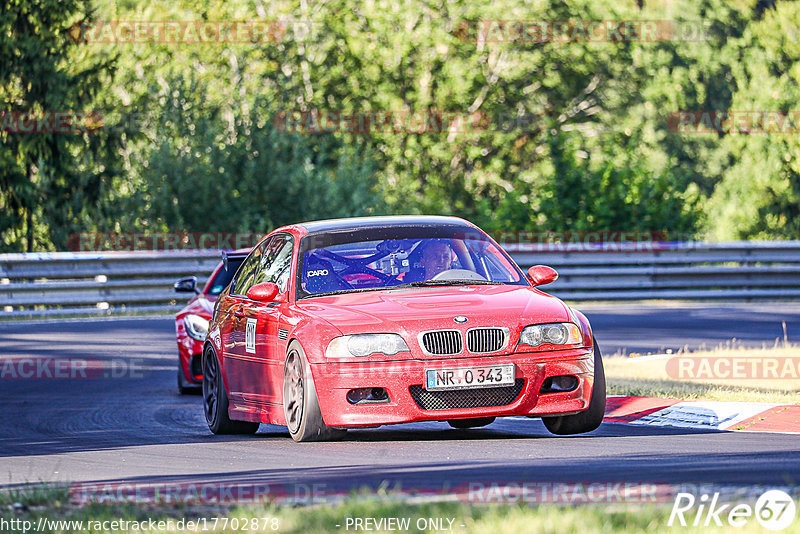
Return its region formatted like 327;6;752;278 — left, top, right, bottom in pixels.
706;2;800;239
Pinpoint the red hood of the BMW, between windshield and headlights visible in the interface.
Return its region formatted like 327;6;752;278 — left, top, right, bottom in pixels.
298;285;571;335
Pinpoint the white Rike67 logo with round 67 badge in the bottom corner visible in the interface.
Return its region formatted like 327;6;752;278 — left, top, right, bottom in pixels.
667;489;796;531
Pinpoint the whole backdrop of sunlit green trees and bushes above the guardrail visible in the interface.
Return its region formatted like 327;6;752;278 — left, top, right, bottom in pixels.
0;0;800;251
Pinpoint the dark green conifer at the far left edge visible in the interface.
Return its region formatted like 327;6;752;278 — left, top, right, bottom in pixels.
0;0;118;251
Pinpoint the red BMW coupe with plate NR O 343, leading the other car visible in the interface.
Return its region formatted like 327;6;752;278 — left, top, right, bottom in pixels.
202;216;606;441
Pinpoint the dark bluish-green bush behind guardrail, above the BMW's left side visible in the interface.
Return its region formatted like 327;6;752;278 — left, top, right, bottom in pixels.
111;76;385;233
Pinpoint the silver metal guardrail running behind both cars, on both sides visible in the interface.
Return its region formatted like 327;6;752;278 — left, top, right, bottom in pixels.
0;241;800;319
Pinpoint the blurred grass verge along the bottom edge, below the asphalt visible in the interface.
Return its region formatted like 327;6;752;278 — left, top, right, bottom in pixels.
0;487;800;534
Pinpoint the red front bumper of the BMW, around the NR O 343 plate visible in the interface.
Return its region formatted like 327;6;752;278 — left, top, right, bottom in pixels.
311;349;594;428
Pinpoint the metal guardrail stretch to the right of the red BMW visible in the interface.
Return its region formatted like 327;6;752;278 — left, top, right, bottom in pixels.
506;241;800;300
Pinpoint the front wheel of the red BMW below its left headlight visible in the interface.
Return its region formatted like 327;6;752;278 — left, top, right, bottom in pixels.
283;341;347;441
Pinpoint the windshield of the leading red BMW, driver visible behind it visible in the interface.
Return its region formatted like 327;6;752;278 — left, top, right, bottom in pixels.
297;226;527;298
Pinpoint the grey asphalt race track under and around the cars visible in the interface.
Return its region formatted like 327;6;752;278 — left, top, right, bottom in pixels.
0;304;800;498
